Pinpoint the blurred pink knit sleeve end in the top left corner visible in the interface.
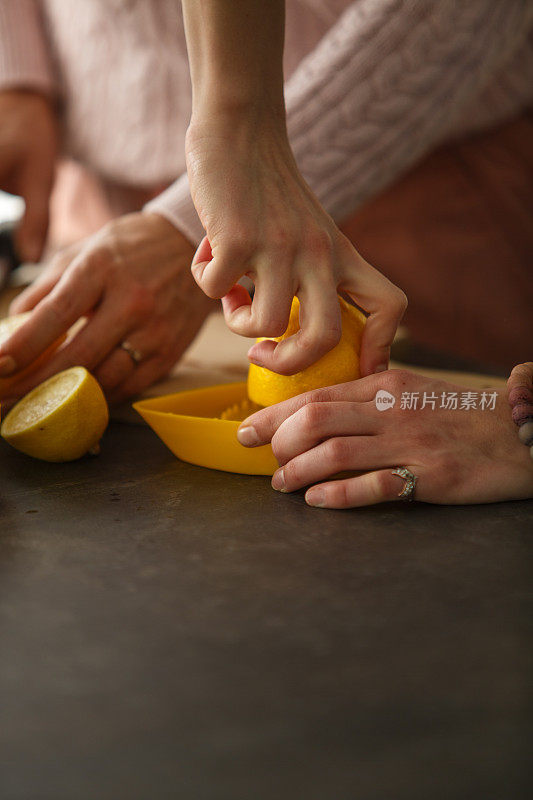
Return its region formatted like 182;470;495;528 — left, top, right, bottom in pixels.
0;0;55;92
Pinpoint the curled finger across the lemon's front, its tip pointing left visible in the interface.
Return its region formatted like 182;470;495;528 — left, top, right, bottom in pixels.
248;274;341;375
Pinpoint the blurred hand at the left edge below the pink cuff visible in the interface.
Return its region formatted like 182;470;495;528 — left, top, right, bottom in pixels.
0;89;59;261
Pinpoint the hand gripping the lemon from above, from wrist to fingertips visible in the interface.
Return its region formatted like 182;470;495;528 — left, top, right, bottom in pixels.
186;115;407;375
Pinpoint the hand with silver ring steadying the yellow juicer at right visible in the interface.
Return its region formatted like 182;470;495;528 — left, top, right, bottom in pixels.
238;370;533;508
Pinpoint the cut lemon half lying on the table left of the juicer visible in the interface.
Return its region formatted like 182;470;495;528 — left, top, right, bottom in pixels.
0;367;109;461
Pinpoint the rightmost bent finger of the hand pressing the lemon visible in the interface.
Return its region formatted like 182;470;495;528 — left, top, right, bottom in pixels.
339;248;407;376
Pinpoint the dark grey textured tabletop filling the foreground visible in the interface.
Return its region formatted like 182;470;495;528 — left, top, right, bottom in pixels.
0;424;533;800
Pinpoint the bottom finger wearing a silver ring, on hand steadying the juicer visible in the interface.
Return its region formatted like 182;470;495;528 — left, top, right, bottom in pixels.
305;467;420;508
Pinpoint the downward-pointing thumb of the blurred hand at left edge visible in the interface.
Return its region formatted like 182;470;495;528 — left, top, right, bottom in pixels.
15;160;52;261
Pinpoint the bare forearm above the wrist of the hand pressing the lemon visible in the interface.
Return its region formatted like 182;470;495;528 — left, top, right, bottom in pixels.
182;0;285;119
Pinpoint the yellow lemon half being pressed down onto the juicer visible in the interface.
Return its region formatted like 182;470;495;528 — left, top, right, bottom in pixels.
248;297;366;406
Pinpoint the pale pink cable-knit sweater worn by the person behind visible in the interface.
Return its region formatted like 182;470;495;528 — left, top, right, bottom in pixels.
0;0;533;242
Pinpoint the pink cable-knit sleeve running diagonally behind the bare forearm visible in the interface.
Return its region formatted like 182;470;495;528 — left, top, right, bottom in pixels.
147;0;533;242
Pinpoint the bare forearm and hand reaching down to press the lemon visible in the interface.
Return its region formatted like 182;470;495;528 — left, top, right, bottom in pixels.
182;0;406;375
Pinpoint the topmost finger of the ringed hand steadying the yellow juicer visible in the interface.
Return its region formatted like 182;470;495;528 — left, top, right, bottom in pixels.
237;375;379;447
